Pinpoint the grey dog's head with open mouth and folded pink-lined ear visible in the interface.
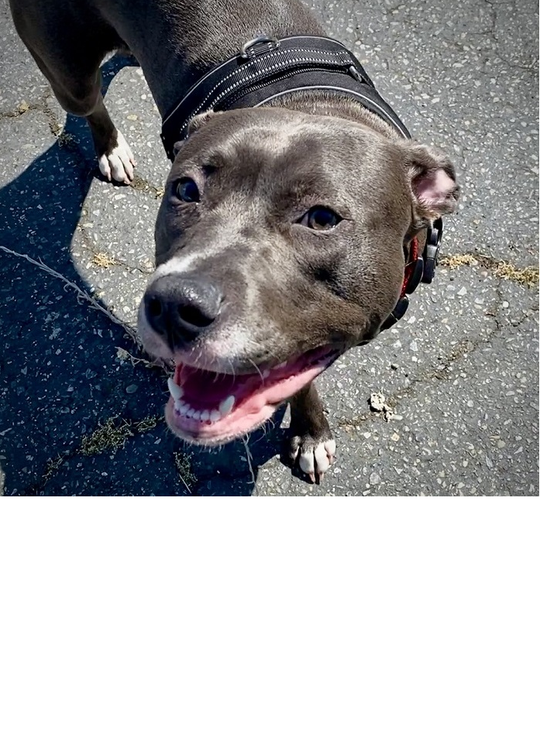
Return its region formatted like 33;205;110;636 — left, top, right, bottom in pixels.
139;108;457;444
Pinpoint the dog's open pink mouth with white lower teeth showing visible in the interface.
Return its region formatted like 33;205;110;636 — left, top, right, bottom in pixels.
165;347;340;445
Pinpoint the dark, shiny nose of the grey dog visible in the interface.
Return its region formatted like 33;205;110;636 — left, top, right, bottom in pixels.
144;274;223;348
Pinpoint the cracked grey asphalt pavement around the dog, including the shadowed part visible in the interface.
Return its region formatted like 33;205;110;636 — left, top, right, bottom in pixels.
0;0;538;496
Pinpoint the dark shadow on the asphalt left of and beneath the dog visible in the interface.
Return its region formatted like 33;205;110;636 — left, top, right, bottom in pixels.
0;55;292;495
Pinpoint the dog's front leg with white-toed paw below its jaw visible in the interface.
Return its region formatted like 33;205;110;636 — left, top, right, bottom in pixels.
283;383;336;483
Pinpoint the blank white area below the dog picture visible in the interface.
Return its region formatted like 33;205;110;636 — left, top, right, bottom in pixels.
0;498;540;755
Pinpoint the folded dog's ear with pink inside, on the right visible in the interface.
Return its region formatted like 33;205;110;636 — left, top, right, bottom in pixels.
406;142;460;220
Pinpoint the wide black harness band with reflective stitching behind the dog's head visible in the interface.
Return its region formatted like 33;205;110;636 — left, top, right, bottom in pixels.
161;36;410;160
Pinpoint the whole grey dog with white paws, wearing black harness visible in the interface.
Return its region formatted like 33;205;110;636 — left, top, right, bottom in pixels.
10;0;458;480
